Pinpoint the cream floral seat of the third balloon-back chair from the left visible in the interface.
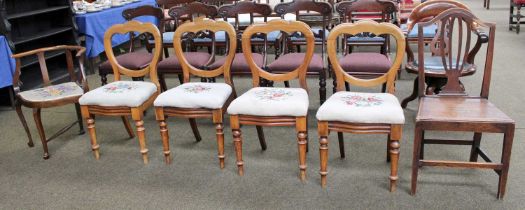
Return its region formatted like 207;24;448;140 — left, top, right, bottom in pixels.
228;87;308;116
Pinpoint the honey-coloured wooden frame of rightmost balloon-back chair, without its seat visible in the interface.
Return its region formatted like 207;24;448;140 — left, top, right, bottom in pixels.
318;20;405;192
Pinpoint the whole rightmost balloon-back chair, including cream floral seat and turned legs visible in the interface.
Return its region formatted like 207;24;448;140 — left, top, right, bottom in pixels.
316;20;405;192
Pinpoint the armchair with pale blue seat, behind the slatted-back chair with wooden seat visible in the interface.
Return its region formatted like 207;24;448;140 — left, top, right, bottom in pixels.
401;0;476;108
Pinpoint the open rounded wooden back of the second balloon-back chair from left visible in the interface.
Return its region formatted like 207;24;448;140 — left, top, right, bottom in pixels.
173;20;237;85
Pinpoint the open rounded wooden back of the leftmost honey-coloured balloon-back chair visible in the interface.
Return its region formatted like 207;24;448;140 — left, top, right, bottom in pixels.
104;20;162;90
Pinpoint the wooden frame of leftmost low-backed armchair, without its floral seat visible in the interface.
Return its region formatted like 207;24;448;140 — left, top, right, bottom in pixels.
12;45;89;159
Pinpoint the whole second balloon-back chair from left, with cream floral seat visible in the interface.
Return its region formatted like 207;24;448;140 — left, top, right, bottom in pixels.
154;20;237;169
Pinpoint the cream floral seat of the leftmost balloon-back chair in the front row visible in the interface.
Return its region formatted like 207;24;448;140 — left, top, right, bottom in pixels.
79;81;157;107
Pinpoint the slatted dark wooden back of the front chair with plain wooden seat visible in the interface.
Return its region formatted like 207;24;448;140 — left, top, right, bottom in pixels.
418;8;496;98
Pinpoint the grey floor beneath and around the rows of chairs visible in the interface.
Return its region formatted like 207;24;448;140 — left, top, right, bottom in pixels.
0;0;525;209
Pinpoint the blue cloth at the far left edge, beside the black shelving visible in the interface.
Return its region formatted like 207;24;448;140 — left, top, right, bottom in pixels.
0;36;16;88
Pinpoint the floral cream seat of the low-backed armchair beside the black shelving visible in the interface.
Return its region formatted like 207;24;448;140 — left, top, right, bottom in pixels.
18;82;84;102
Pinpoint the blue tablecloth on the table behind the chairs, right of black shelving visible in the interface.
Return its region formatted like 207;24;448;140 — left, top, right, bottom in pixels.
75;0;157;58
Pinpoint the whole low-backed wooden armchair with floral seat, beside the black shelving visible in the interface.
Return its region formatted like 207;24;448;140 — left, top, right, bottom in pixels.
13;45;89;159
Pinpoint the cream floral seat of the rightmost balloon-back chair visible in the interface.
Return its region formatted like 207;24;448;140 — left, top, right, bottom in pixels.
316;91;405;124
